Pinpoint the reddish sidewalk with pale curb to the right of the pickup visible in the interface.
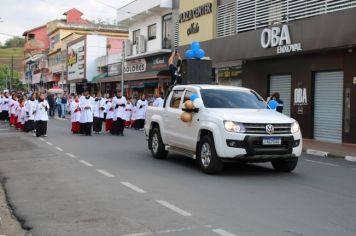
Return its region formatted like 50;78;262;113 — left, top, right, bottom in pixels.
303;139;356;161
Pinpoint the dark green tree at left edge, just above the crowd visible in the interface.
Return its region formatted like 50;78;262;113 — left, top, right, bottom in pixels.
0;64;25;91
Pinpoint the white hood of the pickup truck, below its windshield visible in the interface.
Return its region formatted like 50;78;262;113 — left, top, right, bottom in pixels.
206;108;295;124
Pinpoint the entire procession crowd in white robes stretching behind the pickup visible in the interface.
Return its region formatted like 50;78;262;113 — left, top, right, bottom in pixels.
0;91;164;137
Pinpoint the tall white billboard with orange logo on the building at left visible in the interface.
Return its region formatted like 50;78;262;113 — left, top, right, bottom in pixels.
67;40;85;80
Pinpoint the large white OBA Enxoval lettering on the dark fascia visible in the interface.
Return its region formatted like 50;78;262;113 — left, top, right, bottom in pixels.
261;25;302;54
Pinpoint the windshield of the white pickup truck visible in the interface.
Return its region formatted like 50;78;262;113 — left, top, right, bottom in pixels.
200;89;267;109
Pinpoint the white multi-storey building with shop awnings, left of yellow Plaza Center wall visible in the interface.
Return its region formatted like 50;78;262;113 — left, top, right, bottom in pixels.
99;0;174;97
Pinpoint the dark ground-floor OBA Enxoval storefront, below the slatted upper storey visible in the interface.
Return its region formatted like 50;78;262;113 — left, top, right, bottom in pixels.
180;4;356;143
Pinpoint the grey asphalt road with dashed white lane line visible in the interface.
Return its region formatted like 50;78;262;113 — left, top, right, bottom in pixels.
0;120;356;236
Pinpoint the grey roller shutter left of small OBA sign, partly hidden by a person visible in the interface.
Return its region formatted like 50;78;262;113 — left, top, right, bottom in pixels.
269;75;291;116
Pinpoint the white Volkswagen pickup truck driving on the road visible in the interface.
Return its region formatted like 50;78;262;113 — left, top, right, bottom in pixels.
145;85;302;174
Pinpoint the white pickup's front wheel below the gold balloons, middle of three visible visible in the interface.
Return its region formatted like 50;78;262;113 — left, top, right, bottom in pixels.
197;135;224;174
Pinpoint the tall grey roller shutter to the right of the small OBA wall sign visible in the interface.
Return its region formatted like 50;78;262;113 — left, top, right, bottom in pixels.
314;71;344;143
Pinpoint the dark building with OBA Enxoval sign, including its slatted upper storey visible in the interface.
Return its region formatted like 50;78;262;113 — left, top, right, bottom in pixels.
177;0;356;143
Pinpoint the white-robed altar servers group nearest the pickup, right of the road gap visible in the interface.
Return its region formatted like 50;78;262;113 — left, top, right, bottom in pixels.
69;91;148;136
